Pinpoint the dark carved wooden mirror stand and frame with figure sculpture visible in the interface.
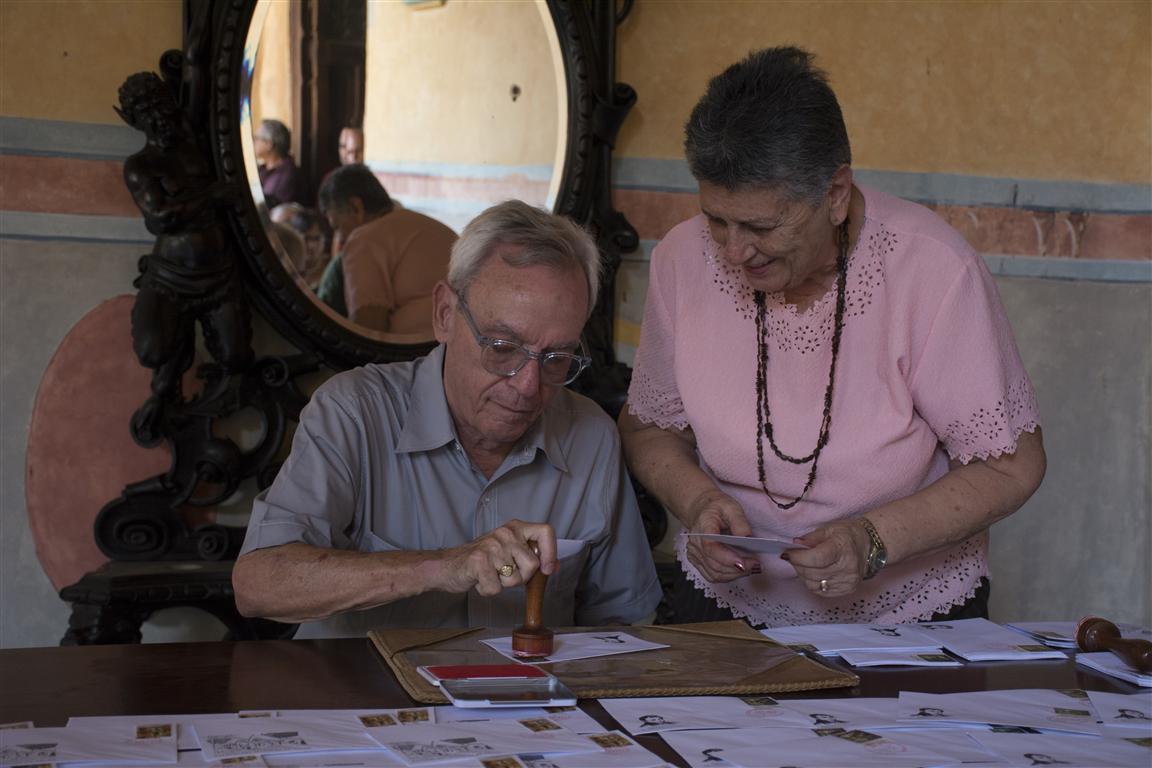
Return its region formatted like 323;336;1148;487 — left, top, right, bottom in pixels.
60;0;649;645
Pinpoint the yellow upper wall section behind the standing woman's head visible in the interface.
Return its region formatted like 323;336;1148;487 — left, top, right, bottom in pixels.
617;0;1152;183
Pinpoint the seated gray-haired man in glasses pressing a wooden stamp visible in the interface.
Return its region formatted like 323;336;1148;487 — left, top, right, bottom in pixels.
233;201;660;637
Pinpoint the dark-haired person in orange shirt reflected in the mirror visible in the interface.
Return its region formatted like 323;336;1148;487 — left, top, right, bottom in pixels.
320;165;456;339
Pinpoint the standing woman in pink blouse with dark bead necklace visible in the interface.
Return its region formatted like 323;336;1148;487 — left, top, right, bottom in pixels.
620;48;1045;626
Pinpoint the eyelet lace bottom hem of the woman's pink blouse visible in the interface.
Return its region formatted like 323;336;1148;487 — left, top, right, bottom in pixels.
676;535;987;628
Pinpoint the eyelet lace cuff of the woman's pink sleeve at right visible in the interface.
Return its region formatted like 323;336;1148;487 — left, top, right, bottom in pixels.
940;379;1040;464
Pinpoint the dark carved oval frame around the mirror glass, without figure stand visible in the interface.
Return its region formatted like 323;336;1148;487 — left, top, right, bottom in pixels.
208;0;638;373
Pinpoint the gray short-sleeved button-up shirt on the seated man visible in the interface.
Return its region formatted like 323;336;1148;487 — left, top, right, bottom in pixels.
241;347;660;638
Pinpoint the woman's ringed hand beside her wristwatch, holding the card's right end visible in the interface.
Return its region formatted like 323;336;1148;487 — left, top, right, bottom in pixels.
781;518;871;598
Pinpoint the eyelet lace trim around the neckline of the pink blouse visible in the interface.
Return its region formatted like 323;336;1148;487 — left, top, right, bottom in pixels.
700;218;880;355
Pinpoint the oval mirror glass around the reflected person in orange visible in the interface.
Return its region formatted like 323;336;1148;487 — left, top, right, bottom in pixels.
240;0;568;344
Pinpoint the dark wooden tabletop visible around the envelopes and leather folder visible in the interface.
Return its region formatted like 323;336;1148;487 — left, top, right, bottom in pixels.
0;639;1140;766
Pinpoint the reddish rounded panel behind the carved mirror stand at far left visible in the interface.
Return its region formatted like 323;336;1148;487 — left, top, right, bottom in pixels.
24;296;170;590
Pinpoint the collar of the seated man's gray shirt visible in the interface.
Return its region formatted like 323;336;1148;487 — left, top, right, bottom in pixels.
396;344;573;472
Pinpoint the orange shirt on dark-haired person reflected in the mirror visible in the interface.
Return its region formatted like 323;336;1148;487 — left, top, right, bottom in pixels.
342;206;456;339
